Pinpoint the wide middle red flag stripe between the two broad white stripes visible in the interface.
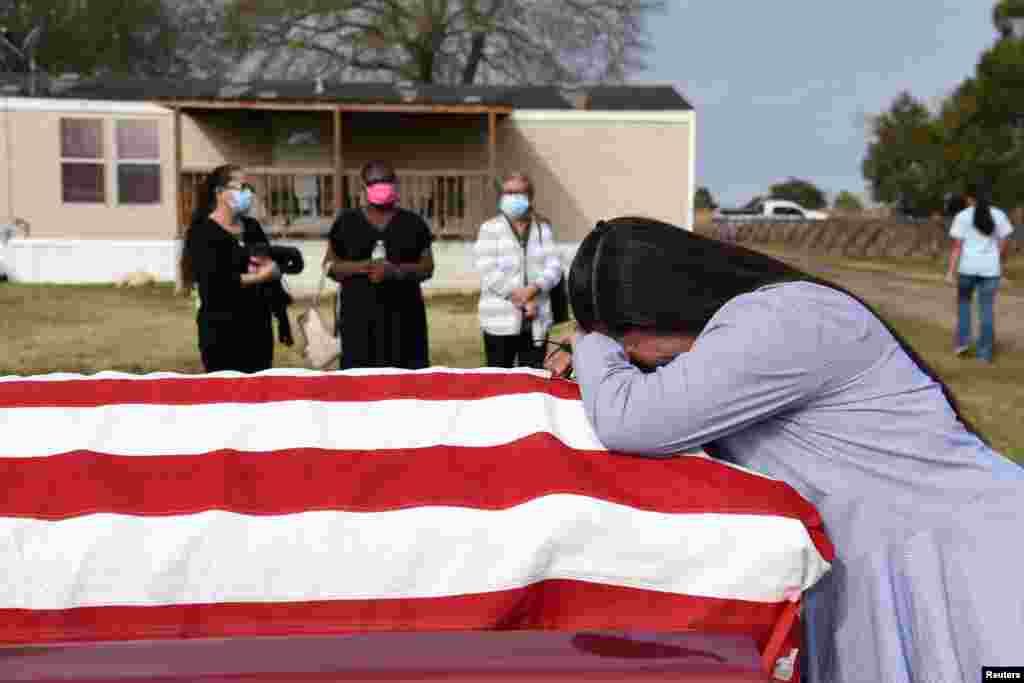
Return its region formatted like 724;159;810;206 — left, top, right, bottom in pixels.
0;433;833;561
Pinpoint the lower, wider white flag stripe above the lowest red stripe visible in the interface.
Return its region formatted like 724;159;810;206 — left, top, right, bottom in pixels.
0;495;828;609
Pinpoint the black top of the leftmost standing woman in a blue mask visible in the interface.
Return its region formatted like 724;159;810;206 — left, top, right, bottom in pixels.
186;217;270;318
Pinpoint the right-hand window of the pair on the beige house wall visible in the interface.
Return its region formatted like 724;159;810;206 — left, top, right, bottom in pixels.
114;119;161;205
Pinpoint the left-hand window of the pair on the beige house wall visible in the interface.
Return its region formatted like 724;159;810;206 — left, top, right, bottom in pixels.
60;119;106;204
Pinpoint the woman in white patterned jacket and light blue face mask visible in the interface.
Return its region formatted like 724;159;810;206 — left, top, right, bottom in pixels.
473;173;562;368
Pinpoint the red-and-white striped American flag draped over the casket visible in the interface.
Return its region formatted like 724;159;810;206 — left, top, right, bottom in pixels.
0;369;833;680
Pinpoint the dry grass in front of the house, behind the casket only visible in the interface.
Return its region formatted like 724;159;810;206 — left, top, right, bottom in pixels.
0;283;483;375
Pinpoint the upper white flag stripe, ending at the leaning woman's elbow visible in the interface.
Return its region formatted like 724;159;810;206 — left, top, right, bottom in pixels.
0;393;605;458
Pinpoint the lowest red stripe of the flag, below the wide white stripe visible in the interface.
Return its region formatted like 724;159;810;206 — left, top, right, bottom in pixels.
0;580;787;644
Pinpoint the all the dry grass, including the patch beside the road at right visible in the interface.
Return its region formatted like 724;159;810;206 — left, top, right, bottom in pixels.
0;280;1024;462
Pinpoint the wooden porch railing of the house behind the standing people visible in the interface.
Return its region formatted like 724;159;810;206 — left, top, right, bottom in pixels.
178;167;496;240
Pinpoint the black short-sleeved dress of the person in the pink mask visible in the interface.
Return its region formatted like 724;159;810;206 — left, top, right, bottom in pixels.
328;209;433;370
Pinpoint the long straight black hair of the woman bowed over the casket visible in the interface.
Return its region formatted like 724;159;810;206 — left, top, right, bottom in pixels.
568;217;988;444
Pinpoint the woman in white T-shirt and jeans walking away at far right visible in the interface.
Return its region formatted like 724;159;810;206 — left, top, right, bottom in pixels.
946;182;1014;362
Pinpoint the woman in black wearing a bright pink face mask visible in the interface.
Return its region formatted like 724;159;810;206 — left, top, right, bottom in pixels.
325;161;434;370
